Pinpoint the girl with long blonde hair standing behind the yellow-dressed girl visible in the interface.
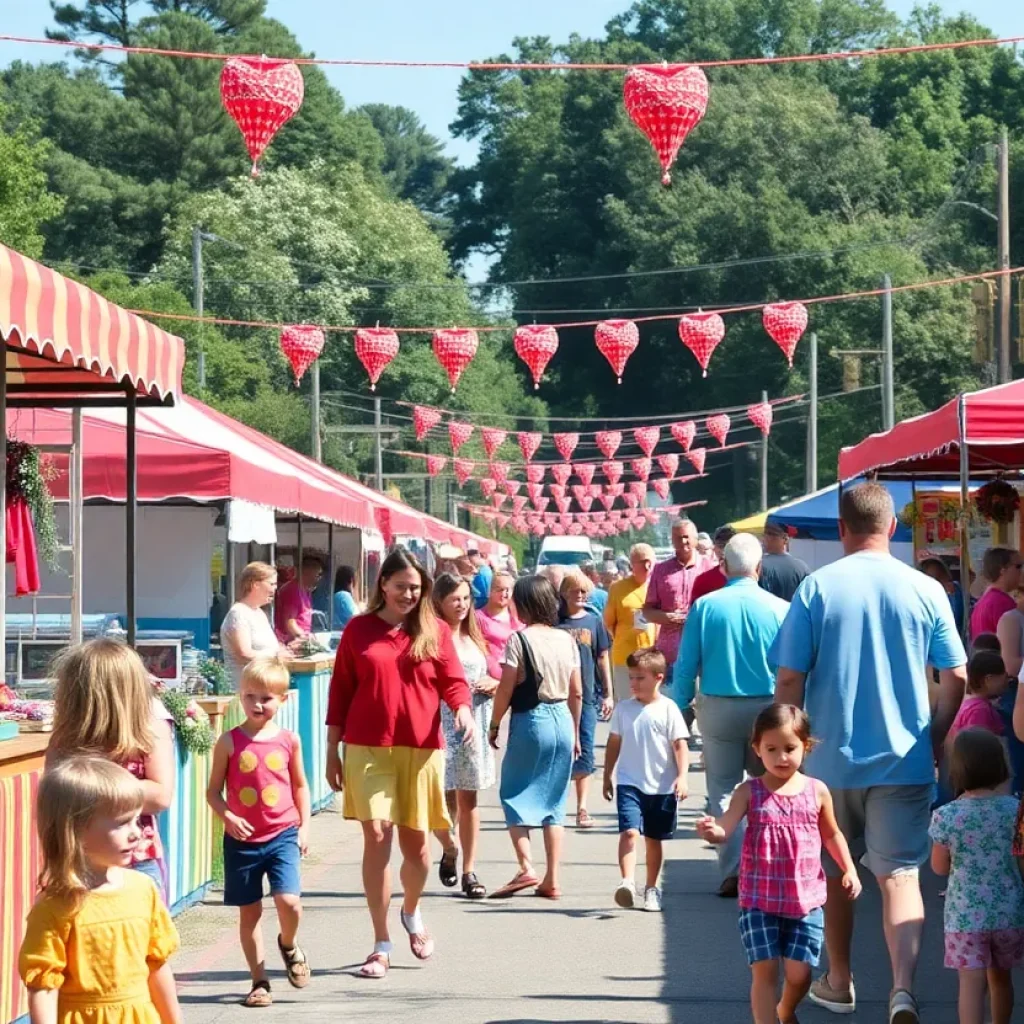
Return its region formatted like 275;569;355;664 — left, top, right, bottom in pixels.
46;638;174;889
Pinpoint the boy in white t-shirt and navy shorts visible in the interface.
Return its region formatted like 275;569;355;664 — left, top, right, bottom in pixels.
604;647;689;911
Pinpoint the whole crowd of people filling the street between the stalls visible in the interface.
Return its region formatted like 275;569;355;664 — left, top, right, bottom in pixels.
20;483;1024;1024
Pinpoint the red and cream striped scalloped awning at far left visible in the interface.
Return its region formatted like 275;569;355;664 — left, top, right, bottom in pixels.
0;245;184;406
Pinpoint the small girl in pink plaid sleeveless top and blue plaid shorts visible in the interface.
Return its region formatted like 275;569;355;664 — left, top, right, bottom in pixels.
697;705;860;1024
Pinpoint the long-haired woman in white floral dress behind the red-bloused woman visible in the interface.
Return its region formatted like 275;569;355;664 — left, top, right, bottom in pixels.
434;572;498;899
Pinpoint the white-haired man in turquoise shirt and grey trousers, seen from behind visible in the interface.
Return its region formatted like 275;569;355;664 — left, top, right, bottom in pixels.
673;534;790;897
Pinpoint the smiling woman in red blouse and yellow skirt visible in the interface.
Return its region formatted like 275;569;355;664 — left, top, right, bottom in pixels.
327;549;480;978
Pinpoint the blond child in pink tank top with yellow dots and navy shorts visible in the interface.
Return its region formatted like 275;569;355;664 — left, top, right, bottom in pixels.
206;657;310;1007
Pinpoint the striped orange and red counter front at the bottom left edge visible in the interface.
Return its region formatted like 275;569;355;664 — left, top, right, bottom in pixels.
0;768;43;1022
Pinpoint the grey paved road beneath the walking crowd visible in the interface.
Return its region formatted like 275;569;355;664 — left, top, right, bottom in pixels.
175;724;956;1024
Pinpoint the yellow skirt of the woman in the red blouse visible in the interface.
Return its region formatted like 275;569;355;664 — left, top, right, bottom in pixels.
343;743;452;833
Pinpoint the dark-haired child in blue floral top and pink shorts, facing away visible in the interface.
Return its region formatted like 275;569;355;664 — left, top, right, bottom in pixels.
929;728;1024;1024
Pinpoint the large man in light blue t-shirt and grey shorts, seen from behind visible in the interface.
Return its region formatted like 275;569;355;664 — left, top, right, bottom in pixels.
770;483;967;1024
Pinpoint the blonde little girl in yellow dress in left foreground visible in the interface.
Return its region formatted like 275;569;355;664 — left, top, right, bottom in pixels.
18;757;181;1024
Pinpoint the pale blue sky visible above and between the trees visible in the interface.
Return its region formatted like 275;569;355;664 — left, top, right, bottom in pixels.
0;0;1024;159
